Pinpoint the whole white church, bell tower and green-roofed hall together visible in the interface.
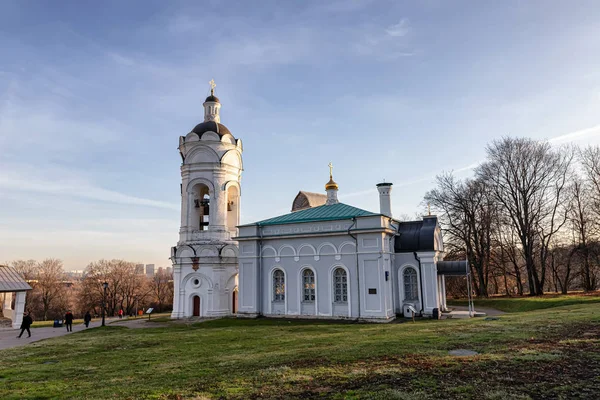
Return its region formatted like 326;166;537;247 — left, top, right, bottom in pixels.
171;81;465;321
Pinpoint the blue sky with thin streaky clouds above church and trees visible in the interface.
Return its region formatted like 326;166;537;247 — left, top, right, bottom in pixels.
0;0;600;270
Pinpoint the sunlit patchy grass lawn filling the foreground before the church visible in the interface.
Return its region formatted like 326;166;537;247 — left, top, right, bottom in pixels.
0;302;600;399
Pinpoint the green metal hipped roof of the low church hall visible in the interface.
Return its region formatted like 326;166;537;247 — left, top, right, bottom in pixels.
248;203;377;226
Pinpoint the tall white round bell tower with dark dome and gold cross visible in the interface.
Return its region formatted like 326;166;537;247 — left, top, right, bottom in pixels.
171;80;243;318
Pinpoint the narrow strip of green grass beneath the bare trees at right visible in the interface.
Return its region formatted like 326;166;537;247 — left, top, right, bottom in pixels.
448;294;600;313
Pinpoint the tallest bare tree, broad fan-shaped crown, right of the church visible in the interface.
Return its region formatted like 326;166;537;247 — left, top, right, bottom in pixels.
477;138;573;295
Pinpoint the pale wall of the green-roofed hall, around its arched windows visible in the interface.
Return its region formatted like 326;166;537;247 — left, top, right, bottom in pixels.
239;218;395;320
